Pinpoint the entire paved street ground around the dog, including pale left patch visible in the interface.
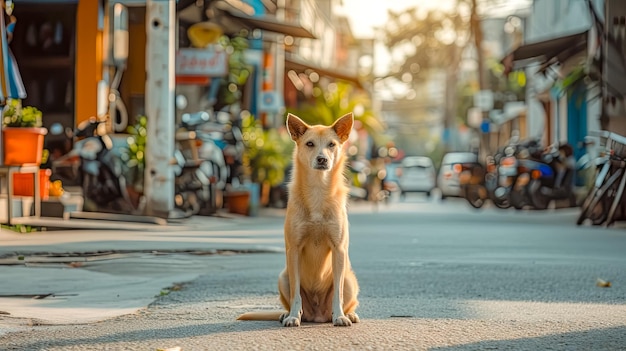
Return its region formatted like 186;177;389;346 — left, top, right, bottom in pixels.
0;196;626;350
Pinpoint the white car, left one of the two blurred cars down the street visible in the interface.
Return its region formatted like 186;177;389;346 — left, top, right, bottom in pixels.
397;156;436;197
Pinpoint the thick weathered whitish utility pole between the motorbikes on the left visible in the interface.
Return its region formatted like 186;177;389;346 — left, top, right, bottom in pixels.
144;0;176;218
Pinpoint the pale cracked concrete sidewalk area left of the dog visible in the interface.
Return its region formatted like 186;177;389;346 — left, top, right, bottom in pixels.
0;210;283;335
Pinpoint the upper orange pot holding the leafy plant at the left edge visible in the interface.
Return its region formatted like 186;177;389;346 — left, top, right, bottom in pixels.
2;127;48;166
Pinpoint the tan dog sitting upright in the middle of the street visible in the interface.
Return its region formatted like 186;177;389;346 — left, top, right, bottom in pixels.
238;113;359;327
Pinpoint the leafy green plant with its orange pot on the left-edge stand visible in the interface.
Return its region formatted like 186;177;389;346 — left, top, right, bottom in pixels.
2;99;48;165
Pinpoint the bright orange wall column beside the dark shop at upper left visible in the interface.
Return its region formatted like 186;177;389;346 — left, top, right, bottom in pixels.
74;0;102;124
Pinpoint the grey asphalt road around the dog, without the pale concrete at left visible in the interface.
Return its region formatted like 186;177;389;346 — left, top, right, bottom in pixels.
0;196;626;351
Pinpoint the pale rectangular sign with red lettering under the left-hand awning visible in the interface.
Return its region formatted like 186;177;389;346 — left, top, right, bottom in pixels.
176;48;228;77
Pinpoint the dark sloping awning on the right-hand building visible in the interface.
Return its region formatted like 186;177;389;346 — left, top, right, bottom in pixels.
502;30;589;74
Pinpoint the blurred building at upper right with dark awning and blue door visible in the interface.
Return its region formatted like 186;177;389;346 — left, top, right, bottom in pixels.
503;0;626;157
